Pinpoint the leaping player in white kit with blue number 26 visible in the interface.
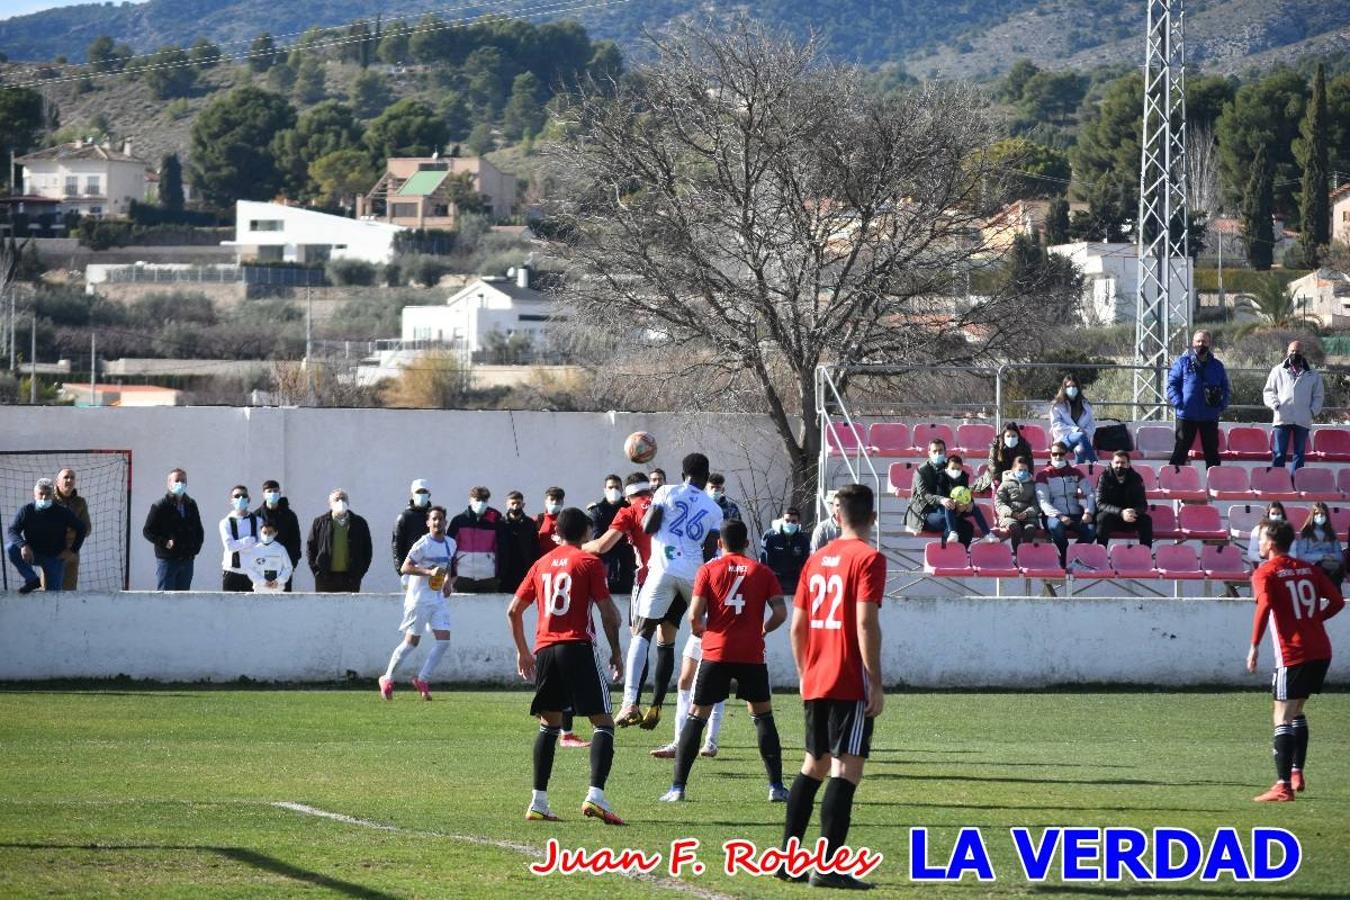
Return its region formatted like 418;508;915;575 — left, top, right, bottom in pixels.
618;453;722;730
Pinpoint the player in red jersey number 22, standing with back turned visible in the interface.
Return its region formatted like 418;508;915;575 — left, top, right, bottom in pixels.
783;484;886;889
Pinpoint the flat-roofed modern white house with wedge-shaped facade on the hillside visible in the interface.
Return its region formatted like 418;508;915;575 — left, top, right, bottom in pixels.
221;200;404;264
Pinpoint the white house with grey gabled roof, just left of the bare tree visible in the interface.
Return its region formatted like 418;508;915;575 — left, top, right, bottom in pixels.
402;266;562;354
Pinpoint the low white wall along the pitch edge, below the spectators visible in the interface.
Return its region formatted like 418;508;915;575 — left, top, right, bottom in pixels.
0;592;1350;690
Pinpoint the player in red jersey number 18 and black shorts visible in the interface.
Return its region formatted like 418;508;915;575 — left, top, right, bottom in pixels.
506;507;624;824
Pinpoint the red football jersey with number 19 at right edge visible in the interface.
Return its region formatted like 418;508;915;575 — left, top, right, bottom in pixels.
1251;556;1346;668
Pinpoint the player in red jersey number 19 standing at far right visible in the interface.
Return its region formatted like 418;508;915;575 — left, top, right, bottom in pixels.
1247;519;1346;803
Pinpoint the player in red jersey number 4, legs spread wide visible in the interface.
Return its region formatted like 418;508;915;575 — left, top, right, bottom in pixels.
662;519;787;803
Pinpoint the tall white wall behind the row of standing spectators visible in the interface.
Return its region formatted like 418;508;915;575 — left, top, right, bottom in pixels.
0;406;786;591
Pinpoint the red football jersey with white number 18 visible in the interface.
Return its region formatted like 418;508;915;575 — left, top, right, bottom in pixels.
516;544;609;653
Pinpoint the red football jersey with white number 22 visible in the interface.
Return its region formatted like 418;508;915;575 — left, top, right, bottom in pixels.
794;538;886;700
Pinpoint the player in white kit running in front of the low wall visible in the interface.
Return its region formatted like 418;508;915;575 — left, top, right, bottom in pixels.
379;506;455;700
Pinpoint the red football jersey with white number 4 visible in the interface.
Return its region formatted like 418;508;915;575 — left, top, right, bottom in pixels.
694;553;783;663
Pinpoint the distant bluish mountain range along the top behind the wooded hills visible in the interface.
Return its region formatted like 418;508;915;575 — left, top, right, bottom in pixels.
0;0;1350;78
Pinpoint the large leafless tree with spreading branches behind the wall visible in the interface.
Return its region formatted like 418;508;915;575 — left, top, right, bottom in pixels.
545;20;1075;502
